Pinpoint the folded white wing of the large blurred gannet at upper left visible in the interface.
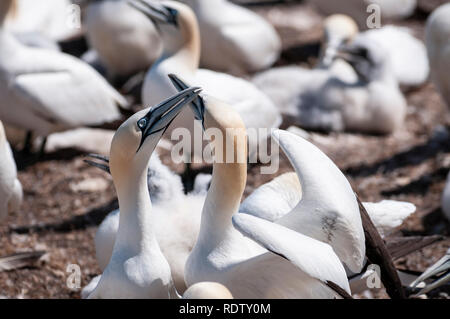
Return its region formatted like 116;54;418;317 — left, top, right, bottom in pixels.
5;49;127;134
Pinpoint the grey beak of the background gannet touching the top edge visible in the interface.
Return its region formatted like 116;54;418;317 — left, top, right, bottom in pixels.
127;0;178;26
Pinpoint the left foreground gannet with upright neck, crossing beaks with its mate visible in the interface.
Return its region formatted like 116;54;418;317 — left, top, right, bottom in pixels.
88;88;198;298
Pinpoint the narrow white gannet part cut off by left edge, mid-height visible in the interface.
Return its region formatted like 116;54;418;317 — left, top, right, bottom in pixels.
0;121;23;219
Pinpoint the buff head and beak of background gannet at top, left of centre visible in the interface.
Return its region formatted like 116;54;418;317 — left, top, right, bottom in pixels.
128;0;200;55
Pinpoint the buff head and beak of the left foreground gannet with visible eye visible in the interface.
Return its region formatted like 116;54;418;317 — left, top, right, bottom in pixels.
110;87;200;182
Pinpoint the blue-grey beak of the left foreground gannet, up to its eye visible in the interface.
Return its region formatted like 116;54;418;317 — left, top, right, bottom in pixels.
137;87;201;151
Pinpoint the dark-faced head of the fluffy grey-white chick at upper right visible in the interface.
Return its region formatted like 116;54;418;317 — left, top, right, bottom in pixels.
336;36;390;82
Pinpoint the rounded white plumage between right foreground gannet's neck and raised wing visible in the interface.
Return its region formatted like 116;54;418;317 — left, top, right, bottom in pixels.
239;172;302;222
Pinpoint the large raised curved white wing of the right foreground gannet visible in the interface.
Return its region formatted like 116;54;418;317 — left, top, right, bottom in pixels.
272;130;365;273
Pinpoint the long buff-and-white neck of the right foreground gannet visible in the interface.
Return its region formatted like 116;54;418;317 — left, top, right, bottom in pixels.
198;97;247;249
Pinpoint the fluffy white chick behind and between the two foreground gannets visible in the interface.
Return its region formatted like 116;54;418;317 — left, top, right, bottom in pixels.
95;154;206;293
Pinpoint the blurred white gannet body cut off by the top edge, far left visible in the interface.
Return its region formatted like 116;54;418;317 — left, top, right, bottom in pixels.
4;0;81;41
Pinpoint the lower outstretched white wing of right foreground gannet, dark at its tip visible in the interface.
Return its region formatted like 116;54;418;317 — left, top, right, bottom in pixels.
233;214;351;297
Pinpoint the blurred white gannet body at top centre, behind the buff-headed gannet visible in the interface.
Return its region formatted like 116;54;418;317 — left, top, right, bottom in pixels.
178;0;281;75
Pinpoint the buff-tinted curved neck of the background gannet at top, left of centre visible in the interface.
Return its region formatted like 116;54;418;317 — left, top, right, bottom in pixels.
161;1;201;71
